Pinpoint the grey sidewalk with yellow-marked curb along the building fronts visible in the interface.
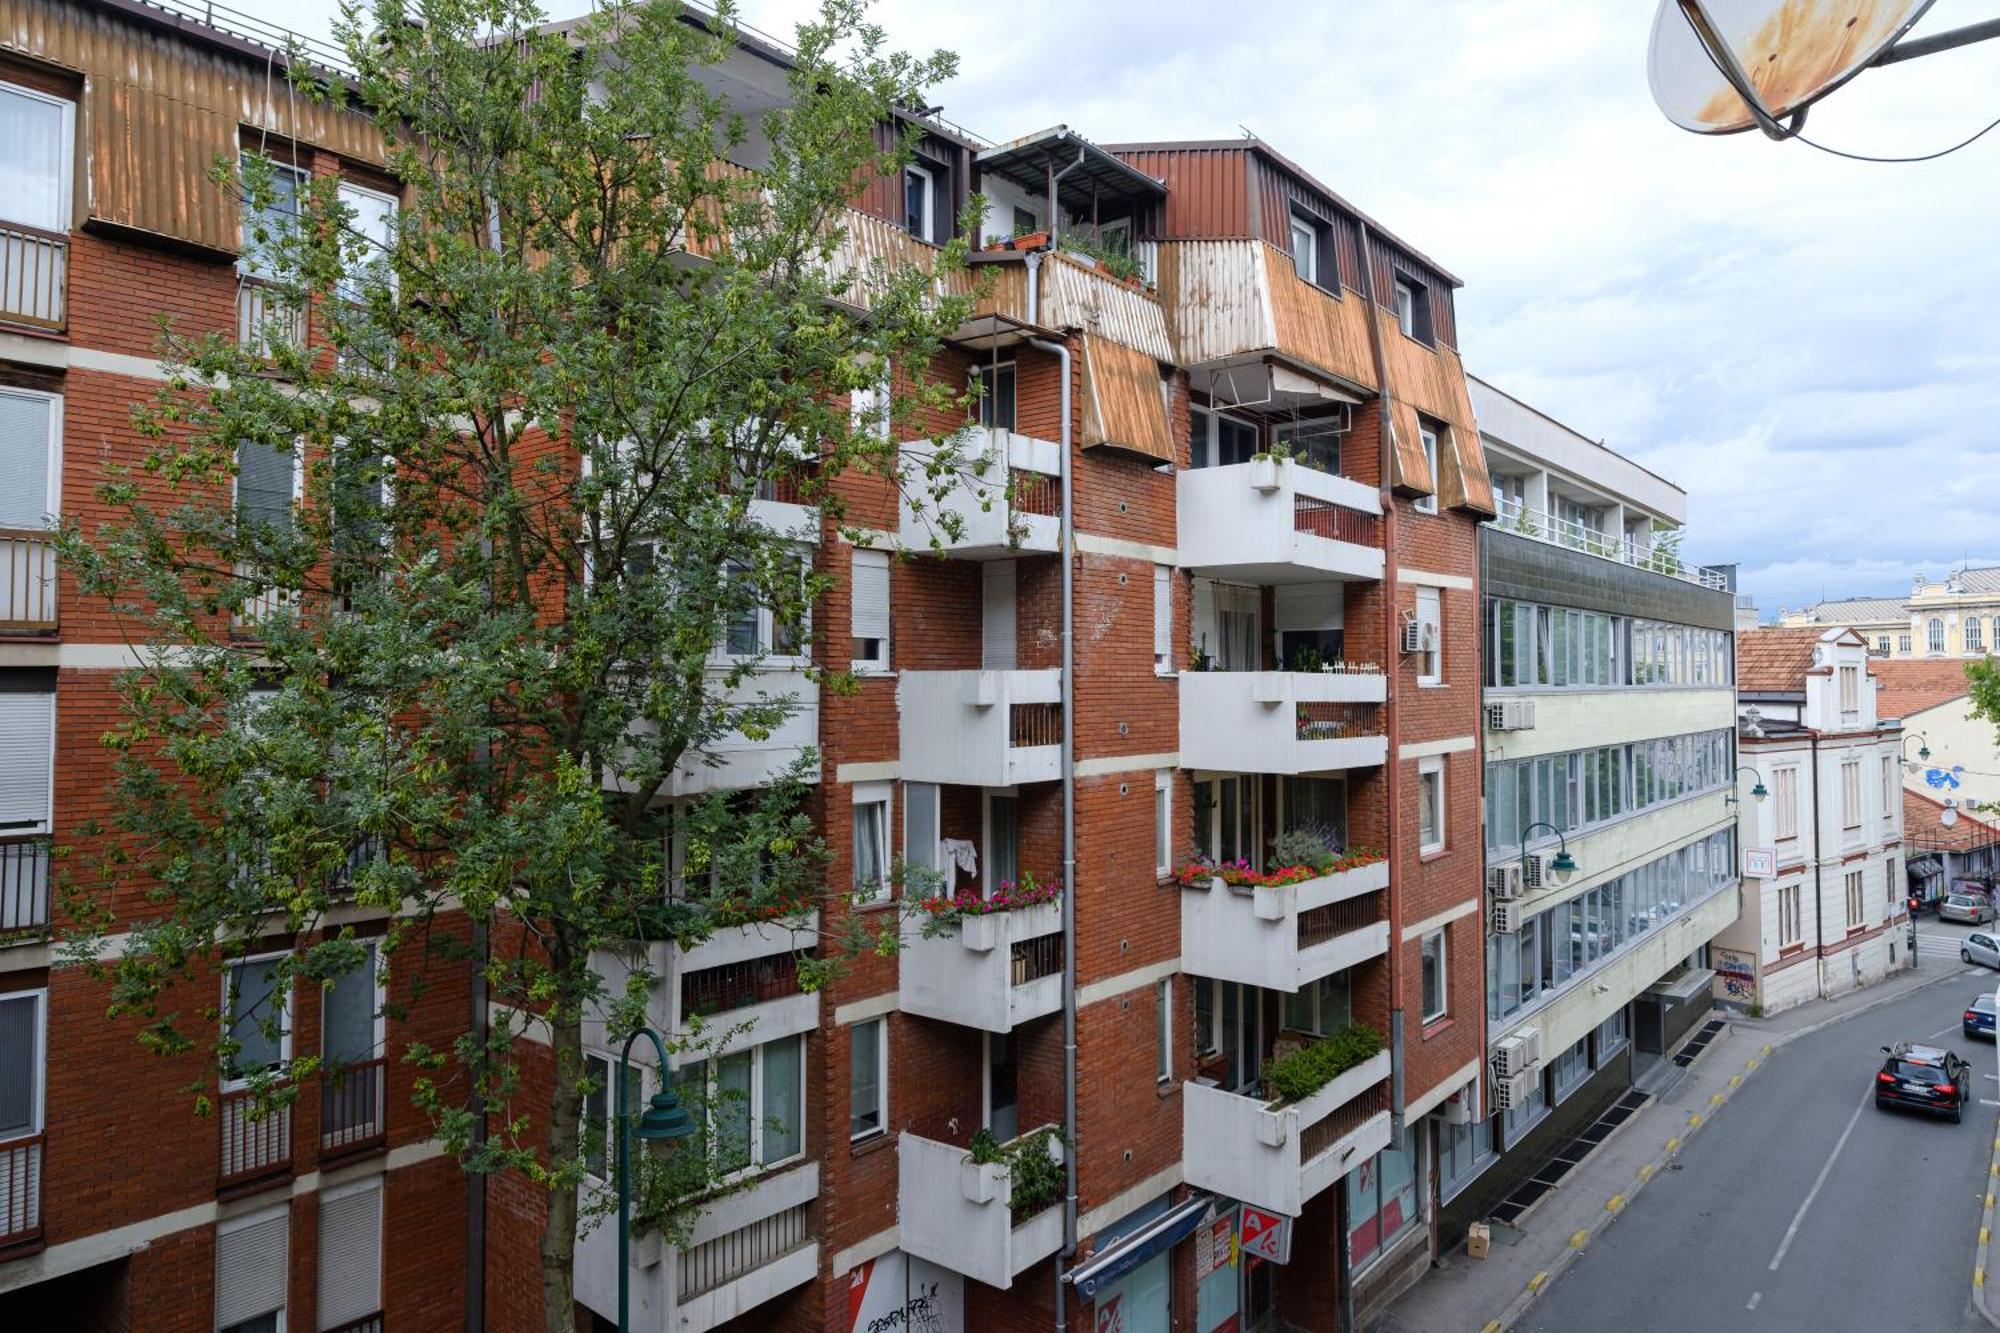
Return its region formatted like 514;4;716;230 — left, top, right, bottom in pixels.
1366;965;1952;1333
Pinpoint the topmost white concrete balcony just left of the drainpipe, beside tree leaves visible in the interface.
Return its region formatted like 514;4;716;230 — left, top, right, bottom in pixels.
902;426;1062;560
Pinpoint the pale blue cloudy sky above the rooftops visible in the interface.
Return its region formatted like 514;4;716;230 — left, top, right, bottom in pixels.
266;0;2000;616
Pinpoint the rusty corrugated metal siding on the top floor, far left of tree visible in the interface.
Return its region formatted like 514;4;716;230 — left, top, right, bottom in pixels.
0;0;384;250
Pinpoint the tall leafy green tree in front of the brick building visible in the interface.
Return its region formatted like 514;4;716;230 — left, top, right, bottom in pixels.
62;0;970;1331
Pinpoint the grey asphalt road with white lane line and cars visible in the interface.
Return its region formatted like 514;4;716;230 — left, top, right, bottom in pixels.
1516;964;2000;1333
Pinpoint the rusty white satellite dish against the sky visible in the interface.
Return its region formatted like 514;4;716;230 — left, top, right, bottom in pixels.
1646;0;1932;138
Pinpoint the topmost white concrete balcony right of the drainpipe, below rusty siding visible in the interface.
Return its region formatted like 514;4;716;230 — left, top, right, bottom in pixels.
1178;458;1382;582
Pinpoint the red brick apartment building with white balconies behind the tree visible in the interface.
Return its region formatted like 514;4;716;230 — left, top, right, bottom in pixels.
0;0;1492;1333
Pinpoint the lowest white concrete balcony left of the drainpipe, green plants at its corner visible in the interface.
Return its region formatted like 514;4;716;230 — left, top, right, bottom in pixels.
896;1125;1062;1289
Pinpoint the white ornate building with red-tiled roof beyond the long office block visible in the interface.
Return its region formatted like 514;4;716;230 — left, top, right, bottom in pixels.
1714;626;1914;1013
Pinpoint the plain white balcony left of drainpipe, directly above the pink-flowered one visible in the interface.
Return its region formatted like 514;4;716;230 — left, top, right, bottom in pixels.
896;667;1062;787
